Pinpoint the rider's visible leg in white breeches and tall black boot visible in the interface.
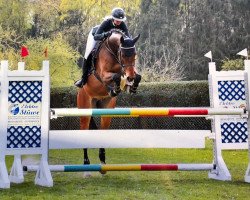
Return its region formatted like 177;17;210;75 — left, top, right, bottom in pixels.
75;29;96;87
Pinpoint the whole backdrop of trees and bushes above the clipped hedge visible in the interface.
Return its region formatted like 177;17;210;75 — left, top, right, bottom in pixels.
0;0;250;86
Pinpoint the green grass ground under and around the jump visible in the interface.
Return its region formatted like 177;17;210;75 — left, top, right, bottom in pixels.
0;143;250;200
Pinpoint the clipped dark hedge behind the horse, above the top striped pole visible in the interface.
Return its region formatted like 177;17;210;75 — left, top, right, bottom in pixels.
51;81;209;108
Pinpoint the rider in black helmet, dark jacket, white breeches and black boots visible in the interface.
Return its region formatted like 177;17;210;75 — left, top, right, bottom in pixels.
75;8;129;87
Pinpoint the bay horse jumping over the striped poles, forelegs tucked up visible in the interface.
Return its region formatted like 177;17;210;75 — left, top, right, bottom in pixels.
77;30;141;176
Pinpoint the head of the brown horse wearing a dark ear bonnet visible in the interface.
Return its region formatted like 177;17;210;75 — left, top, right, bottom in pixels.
120;35;140;82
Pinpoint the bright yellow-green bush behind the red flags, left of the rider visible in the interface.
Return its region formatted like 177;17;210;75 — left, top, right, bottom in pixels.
25;34;80;87
